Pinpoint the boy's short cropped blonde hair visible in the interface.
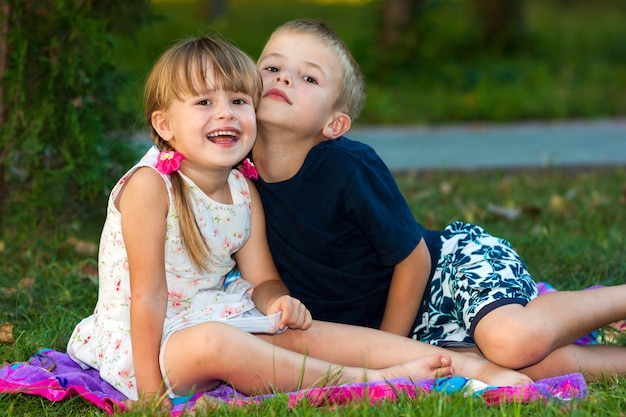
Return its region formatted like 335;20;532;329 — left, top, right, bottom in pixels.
270;19;365;120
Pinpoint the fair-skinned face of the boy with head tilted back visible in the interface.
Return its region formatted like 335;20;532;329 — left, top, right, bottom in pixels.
257;33;343;137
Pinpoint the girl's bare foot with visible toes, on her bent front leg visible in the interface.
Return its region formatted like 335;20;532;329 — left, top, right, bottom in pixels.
370;354;454;381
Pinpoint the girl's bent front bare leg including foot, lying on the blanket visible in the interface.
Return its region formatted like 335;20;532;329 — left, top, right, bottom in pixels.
163;322;452;395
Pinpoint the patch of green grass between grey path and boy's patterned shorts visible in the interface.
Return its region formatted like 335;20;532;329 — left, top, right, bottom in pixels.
399;168;626;289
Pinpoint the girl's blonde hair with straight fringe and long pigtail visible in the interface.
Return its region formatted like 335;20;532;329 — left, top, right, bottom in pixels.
144;35;263;271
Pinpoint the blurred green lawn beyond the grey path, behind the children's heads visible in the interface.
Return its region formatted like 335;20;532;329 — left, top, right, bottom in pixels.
111;0;626;125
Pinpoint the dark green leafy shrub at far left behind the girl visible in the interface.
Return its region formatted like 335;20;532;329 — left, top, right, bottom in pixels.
0;0;149;251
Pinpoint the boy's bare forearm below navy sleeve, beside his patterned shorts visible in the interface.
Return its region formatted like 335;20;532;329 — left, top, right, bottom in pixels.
380;239;430;336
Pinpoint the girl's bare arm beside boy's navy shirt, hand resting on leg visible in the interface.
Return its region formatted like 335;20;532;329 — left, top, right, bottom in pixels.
235;181;311;329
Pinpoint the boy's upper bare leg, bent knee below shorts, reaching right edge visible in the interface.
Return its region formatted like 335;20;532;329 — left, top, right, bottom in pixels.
474;285;626;369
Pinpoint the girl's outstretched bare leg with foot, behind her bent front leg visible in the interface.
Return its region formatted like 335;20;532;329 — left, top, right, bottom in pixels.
262;320;532;385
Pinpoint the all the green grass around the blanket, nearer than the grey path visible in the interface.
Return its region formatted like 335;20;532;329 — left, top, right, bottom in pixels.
0;168;626;417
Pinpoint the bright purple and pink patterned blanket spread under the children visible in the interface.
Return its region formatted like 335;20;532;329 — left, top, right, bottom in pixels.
0;349;587;416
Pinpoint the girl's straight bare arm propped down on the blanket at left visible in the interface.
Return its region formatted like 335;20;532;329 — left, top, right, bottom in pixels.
117;168;169;404
